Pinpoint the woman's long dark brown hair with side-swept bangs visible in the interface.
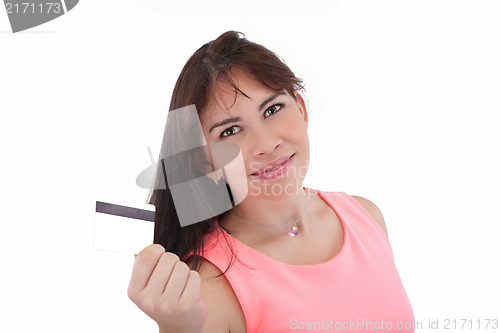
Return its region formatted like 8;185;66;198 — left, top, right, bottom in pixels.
149;31;304;271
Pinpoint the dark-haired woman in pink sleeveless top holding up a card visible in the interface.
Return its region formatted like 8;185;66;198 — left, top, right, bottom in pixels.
128;31;414;333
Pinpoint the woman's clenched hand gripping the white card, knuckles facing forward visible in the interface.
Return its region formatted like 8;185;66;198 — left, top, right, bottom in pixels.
128;244;207;333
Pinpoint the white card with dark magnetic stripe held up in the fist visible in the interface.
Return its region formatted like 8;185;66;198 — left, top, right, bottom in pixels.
94;199;156;254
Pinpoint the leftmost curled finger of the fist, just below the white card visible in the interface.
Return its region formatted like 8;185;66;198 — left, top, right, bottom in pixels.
128;244;165;297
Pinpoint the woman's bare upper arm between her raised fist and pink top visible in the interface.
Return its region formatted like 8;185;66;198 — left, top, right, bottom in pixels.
186;259;246;333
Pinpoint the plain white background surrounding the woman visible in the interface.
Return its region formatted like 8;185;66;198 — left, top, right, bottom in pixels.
0;0;500;332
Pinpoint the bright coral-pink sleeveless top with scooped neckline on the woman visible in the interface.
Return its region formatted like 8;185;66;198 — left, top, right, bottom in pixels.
186;187;414;333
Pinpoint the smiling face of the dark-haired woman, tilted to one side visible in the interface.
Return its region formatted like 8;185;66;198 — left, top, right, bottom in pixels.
200;71;310;198
